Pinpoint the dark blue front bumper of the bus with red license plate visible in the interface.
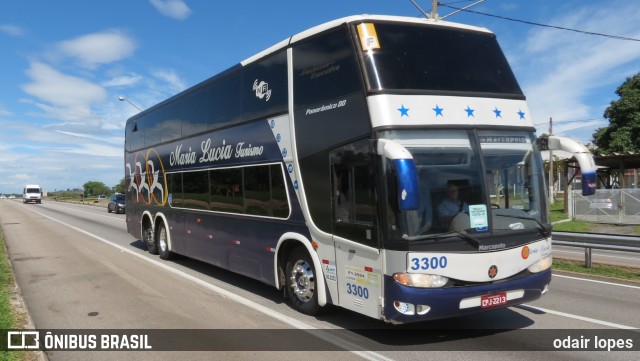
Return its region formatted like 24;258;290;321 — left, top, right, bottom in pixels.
383;269;551;323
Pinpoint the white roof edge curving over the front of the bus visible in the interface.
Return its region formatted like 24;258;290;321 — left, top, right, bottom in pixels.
240;15;491;66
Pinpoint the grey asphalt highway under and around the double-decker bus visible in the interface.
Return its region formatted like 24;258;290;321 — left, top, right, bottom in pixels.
0;200;640;360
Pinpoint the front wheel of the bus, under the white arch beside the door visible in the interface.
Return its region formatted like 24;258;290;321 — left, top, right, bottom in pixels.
285;247;320;315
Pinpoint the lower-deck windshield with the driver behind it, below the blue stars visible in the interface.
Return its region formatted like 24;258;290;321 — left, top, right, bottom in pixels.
380;130;547;240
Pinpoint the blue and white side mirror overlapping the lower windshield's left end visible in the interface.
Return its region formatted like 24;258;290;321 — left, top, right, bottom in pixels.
377;139;420;211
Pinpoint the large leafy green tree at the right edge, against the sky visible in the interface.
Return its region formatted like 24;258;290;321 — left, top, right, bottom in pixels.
593;73;640;153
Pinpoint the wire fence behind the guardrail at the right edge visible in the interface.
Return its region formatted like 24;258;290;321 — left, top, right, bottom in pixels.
569;189;640;224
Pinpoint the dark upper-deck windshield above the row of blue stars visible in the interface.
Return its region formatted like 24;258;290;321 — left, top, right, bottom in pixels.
363;22;522;96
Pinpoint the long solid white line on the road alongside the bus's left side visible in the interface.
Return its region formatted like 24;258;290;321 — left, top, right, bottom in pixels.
25;205;393;361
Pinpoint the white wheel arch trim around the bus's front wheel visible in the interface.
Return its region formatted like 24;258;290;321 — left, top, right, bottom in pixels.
273;232;327;306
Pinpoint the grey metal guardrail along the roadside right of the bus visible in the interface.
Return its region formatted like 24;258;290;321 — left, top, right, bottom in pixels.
551;232;640;268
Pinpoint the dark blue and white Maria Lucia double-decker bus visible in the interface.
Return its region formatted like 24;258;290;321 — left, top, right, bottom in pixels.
125;16;595;323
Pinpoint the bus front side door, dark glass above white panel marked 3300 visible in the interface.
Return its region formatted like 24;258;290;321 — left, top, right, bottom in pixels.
331;152;383;318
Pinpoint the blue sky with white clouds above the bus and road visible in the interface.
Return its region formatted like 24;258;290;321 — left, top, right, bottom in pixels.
0;0;640;194
